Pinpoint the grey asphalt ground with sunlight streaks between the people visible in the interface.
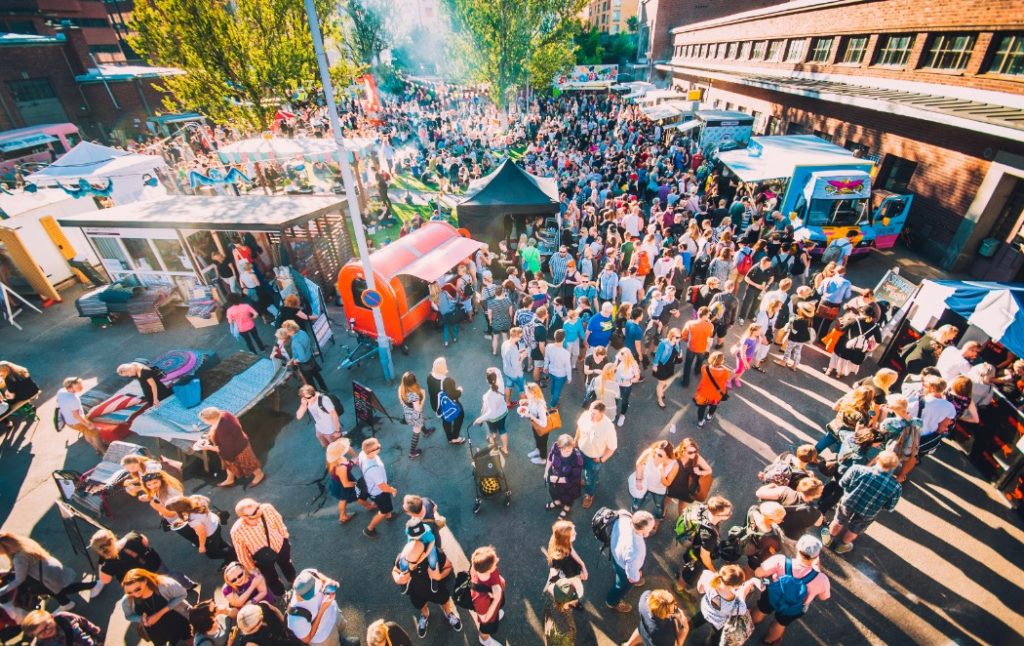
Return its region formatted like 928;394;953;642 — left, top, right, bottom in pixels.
0;244;1024;645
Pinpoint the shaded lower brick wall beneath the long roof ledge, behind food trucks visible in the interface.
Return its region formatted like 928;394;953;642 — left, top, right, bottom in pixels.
675;74;1024;249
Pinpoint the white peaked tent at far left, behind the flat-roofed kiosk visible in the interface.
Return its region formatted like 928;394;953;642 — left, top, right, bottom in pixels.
26;141;167;205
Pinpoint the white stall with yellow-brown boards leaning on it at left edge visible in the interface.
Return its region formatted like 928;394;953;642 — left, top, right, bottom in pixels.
0;188;99;300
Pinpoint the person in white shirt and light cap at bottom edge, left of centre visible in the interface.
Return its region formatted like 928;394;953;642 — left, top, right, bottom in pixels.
287;568;344;646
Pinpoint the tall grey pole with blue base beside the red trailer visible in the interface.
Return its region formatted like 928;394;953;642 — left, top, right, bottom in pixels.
305;0;394;382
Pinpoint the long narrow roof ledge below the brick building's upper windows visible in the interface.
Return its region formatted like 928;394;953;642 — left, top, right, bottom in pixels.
657;64;1024;141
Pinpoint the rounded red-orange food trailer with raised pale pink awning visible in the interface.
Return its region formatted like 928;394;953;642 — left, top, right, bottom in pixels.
337;221;483;345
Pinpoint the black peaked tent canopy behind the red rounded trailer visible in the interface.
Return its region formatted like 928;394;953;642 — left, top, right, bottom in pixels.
456;159;558;244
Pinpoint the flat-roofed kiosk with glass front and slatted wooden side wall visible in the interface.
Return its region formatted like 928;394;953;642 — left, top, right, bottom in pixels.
58;196;352;301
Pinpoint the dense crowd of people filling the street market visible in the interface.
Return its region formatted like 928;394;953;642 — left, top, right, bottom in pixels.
0;79;1024;646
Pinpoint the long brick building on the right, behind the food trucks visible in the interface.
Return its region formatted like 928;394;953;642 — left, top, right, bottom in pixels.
654;0;1024;281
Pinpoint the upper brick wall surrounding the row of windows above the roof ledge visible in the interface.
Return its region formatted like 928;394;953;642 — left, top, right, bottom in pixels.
674;0;1024;93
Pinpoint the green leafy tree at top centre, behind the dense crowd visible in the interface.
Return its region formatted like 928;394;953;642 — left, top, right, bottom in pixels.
445;0;586;107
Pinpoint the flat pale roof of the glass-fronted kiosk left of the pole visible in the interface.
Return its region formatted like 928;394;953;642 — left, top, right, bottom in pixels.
57;196;345;231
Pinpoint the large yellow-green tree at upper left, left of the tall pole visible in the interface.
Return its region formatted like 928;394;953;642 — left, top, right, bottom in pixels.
128;0;355;130
